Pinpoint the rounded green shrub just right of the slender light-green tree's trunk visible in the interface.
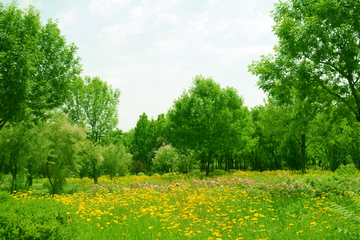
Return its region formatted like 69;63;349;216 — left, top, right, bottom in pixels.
102;144;132;178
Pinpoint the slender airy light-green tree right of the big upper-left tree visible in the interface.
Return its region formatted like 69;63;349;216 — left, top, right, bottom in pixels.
63;76;120;183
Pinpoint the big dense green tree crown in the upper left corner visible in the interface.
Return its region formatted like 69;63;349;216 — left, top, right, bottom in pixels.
0;2;81;130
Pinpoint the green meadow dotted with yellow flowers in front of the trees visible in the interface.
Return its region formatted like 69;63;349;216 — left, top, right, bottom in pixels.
0;170;360;240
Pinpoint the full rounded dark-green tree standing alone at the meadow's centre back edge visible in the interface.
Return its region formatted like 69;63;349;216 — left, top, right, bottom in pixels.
168;75;250;175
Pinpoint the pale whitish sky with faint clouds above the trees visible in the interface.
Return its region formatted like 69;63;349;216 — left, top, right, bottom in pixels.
1;0;278;131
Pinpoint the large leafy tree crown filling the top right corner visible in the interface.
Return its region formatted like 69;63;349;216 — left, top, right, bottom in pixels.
249;0;360;122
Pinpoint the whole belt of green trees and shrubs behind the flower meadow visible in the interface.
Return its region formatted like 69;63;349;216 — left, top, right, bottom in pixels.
0;0;360;193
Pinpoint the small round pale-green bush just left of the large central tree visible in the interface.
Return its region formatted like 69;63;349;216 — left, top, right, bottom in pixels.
152;145;179;173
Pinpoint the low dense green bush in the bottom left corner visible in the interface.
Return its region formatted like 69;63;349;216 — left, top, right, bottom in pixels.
0;199;69;240
